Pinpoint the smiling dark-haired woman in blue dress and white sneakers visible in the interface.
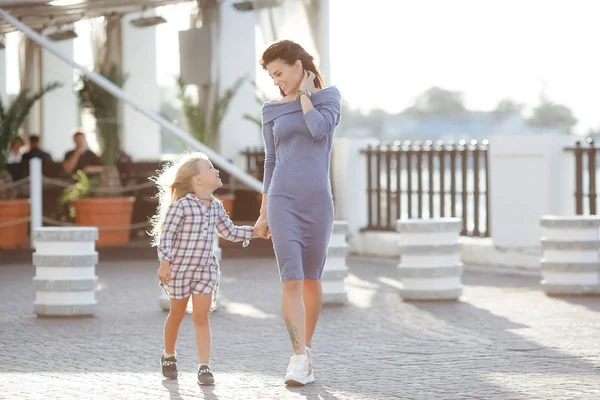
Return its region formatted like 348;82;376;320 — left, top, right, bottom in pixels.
257;40;341;385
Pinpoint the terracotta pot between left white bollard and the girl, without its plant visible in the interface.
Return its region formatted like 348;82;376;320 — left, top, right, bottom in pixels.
73;197;135;247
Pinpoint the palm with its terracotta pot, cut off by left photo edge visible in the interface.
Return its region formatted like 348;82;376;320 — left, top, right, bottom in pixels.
0;82;62;249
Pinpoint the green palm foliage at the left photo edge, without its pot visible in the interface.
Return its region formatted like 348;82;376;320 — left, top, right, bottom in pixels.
0;82;62;198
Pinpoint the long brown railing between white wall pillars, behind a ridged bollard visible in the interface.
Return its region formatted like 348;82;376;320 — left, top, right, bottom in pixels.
364;140;490;237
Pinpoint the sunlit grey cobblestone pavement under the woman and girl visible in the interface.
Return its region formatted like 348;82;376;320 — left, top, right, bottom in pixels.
0;259;600;400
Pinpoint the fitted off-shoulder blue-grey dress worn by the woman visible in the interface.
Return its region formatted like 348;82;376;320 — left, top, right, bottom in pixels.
262;86;341;281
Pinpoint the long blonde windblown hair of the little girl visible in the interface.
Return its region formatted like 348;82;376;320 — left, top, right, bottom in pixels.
149;152;208;246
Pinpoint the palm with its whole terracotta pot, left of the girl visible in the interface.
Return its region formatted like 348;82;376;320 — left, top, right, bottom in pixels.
62;64;135;247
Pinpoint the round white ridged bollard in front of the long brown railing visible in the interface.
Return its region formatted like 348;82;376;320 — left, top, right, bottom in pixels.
396;218;463;300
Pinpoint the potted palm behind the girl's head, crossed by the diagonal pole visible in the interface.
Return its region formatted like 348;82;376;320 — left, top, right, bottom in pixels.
177;73;246;214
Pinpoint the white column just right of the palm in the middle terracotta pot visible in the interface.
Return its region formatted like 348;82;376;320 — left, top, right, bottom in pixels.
122;13;161;161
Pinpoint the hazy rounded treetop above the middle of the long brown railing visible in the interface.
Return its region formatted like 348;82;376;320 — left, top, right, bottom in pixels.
402;86;467;117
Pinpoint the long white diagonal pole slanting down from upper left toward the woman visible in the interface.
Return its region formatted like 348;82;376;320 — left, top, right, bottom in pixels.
0;8;262;192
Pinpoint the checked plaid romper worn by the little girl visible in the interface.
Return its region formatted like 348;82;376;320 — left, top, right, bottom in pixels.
157;193;254;312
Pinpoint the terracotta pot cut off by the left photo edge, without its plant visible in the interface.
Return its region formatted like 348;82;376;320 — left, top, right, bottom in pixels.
0;199;29;249
